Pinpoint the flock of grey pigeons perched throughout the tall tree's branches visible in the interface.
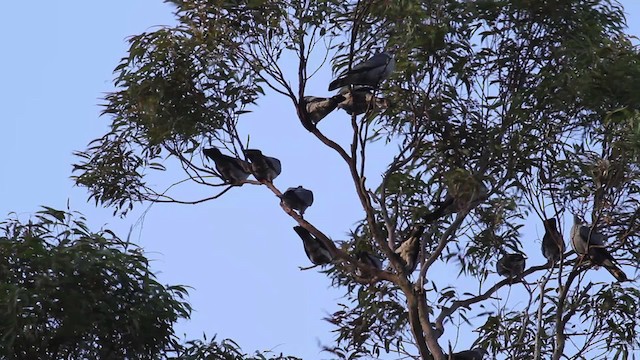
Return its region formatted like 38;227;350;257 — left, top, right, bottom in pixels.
203;51;628;360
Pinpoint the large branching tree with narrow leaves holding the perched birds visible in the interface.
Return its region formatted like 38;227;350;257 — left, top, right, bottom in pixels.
74;0;640;360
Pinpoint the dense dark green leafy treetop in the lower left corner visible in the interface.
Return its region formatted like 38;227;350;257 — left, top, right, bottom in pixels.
0;208;191;359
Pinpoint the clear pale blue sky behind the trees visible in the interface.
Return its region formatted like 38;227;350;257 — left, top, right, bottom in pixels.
0;0;640;359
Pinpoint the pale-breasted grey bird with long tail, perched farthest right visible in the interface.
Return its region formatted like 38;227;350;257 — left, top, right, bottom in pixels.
571;214;628;282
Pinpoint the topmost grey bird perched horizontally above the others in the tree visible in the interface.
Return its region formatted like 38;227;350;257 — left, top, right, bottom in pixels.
329;51;396;91
